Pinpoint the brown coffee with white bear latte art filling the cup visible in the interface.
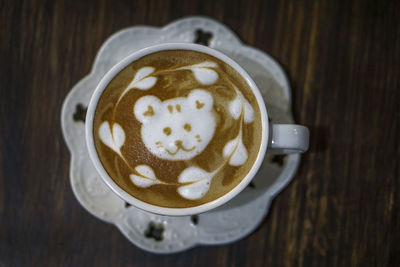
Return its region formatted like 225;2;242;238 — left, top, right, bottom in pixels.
93;50;262;208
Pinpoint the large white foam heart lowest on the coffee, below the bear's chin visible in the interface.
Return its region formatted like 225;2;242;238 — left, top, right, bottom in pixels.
177;167;213;200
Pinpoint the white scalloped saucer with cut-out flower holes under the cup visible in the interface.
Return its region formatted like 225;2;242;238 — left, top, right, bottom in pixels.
61;17;300;253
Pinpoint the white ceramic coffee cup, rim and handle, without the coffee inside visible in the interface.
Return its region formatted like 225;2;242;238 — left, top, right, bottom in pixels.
86;43;309;216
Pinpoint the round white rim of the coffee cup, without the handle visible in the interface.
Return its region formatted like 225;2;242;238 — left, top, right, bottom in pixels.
85;43;269;216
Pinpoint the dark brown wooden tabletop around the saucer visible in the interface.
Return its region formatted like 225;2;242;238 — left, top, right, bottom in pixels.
0;0;400;267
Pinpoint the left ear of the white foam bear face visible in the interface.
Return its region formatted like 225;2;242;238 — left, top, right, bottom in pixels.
133;96;162;123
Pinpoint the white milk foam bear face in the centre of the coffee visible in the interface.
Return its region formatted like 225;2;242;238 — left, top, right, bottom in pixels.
134;89;215;160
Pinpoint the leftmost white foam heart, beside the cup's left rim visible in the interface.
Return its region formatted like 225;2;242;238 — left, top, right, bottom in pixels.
99;121;125;155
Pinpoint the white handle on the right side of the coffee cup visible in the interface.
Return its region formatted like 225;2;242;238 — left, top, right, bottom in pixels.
268;124;310;154
